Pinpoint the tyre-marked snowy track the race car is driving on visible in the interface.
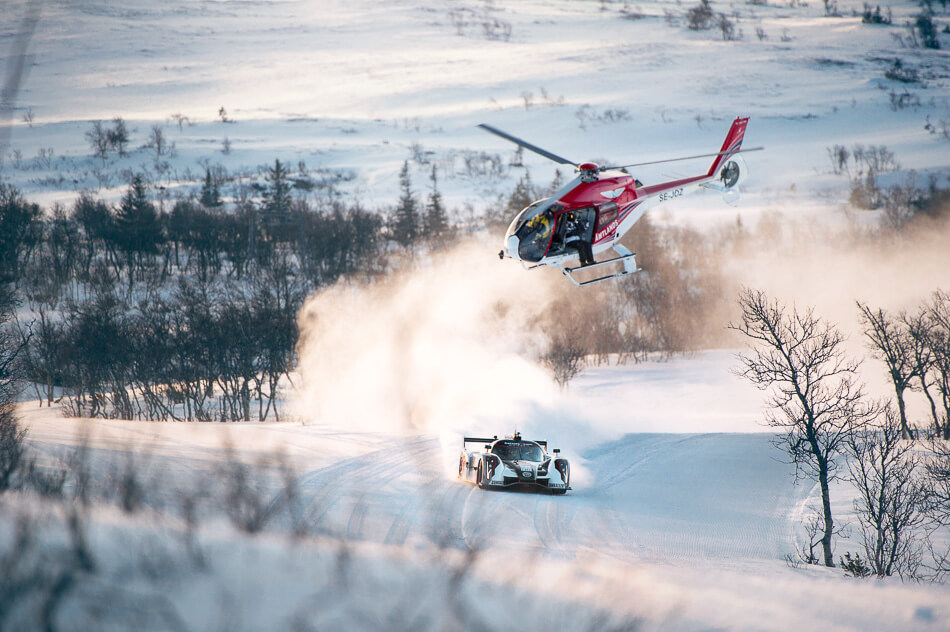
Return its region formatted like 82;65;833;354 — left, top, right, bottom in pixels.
290;434;810;566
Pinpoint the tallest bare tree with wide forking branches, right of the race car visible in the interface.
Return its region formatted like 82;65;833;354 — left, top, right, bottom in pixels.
729;289;873;567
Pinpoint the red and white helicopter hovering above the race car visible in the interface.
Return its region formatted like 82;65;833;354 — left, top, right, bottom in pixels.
479;117;763;286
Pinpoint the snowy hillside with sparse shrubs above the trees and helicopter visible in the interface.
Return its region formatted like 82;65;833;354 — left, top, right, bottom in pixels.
0;0;950;219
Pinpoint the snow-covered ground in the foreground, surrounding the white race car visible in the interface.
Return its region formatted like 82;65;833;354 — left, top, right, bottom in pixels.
11;353;950;630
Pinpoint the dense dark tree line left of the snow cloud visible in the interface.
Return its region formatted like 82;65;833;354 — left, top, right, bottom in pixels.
0;160;462;420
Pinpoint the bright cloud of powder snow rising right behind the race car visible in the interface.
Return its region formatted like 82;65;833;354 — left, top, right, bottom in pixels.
295;244;563;440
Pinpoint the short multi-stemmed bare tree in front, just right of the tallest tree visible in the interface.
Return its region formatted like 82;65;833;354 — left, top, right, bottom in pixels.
848;406;927;577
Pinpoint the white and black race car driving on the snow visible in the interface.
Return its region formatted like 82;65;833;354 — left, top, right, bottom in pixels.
459;432;571;494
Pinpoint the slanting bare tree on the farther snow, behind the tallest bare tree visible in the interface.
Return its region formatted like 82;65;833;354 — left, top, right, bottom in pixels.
858;301;917;439
